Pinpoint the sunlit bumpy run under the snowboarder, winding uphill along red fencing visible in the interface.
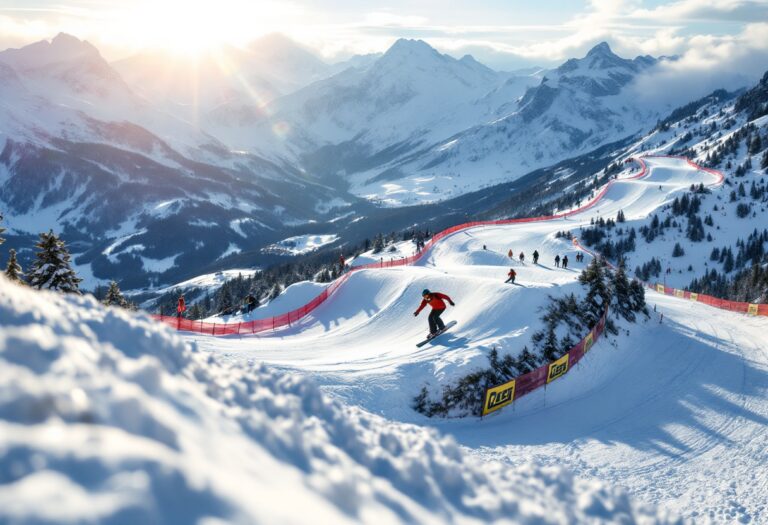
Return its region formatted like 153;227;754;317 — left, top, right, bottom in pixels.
189;158;714;406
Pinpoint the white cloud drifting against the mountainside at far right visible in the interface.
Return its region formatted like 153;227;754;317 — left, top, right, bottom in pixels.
633;22;768;109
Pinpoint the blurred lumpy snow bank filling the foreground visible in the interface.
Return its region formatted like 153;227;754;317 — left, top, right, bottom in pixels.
0;278;655;523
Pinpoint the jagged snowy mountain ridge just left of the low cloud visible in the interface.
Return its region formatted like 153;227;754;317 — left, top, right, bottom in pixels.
344;43;662;204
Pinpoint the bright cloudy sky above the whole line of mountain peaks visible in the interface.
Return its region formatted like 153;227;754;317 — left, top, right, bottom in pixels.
0;0;768;70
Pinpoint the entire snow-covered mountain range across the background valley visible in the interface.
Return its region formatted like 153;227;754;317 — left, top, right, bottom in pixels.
0;31;756;289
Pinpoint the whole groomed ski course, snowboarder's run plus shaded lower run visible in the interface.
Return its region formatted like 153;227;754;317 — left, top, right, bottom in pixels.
187;157;768;522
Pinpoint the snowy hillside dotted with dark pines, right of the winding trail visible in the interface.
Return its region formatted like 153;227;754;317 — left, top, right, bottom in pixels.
573;74;768;301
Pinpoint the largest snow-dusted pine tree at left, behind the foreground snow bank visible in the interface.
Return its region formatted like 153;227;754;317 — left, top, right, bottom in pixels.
28;230;82;295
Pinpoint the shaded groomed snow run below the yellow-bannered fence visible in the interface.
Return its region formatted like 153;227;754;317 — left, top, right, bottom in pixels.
448;292;768;523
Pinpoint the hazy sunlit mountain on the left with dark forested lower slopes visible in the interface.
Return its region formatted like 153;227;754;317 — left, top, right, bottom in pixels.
0;34;368;288
